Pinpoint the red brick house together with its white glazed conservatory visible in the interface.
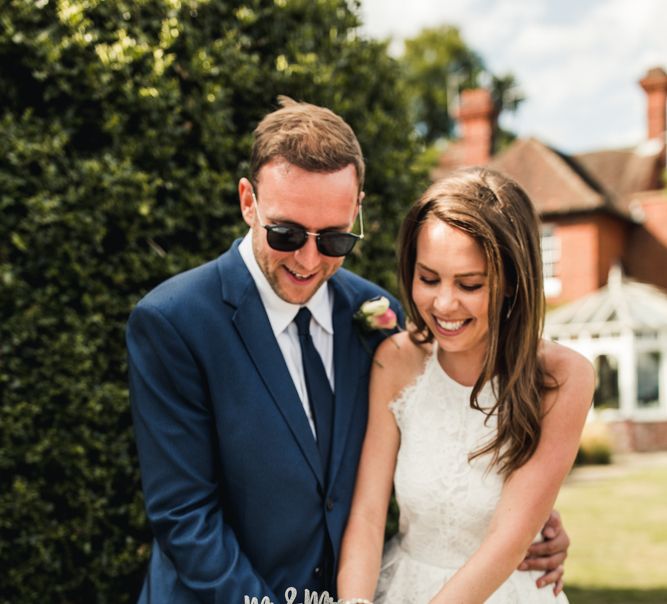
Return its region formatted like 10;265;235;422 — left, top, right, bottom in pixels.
433;68;667;451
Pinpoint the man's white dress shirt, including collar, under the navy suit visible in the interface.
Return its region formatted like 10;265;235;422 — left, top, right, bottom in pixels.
239;231;334;435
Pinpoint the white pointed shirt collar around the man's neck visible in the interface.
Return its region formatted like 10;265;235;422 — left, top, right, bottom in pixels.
239;231;333;336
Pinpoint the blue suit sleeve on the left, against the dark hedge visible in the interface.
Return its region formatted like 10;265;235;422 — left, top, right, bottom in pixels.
127;304;278;604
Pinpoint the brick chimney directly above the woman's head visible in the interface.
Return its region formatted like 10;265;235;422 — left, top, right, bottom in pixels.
457;88;497;166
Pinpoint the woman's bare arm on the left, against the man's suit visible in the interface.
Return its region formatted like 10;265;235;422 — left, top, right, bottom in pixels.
338;332;423;600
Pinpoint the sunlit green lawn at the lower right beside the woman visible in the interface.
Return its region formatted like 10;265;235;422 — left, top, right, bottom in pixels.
557;454;667;604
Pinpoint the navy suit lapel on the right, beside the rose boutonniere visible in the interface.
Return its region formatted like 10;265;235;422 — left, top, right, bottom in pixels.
329;276;365;485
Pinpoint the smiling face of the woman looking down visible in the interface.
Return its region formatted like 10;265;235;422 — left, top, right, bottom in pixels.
412;217;489;369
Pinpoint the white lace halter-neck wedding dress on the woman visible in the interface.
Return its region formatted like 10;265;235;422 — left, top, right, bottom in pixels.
374;353;567;604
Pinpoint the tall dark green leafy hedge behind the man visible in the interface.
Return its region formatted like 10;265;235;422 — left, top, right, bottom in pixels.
0;0;424;604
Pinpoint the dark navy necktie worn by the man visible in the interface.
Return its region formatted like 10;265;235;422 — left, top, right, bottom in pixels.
294;307;334;472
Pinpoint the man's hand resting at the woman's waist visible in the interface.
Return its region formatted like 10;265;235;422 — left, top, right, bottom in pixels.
519;510;570;595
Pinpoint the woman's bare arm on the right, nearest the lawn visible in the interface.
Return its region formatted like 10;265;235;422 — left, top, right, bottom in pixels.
432;347;595;604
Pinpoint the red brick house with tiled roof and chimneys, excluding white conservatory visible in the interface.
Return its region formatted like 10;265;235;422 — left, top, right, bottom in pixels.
434;68;667;305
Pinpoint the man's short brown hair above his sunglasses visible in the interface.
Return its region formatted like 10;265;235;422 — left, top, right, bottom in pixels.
250;96;365;192
